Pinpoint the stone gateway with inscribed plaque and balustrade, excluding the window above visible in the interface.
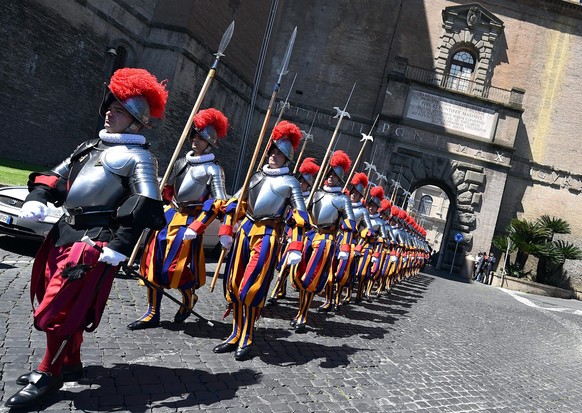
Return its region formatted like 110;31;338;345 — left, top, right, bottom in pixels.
374;66;523;271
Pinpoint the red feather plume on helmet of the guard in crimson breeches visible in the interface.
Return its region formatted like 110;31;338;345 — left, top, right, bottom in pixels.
109;67;168;119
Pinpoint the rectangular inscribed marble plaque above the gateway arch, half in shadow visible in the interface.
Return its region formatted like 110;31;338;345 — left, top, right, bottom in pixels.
404;90;497;140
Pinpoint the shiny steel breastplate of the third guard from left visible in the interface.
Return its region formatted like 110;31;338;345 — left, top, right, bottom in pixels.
247;173;301;220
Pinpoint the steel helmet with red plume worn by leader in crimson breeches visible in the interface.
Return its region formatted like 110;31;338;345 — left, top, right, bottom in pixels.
99;67;168;127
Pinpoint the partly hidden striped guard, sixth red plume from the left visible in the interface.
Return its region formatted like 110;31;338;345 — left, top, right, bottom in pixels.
334;172;374;311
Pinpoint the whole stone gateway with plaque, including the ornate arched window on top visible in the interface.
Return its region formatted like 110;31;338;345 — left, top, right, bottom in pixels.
360;3;524;271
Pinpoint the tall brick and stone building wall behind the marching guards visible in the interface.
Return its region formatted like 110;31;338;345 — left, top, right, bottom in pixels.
0;0;582;290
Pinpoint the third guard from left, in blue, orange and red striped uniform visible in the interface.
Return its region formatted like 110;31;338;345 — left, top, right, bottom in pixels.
214;121;309;360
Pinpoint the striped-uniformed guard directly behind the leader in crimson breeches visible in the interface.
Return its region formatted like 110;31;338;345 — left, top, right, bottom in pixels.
127;108;228;330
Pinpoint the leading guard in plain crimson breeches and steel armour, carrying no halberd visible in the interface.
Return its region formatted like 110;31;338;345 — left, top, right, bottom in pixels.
6;68;168;408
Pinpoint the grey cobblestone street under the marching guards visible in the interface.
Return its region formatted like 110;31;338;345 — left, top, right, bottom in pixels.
0;237;582;413
